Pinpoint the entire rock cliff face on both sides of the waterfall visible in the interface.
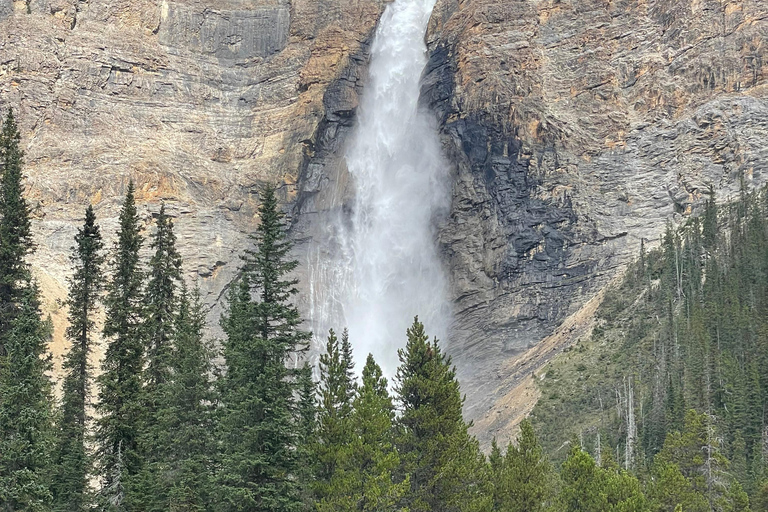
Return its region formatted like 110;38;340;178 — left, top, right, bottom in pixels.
0;0;768;446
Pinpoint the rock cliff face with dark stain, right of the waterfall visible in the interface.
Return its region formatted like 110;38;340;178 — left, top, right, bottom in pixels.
422;0;768;440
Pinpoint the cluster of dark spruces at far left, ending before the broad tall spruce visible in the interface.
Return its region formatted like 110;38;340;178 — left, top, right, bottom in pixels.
0;106;218;512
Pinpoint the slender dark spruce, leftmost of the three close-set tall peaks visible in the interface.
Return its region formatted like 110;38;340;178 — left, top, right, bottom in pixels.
52;206;104;512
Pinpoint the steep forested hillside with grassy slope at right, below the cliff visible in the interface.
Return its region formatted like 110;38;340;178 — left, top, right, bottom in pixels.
533;181;768;510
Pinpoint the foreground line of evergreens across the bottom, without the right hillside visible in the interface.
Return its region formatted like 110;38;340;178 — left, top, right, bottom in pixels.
0;103;757;512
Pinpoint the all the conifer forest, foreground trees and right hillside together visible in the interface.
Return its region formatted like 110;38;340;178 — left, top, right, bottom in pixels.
0;101;768;512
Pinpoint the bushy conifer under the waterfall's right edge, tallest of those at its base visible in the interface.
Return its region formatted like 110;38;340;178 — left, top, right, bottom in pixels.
395;318;492;512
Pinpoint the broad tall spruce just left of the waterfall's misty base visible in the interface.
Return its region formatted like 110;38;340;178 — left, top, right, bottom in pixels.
219;186;310;512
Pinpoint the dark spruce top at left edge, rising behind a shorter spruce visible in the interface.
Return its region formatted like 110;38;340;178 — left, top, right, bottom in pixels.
0;109;33;355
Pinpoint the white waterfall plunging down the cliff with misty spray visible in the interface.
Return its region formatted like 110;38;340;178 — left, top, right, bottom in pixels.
310;0;450;376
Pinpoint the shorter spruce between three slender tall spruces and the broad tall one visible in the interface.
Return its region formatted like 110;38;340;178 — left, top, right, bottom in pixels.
137;284;216;512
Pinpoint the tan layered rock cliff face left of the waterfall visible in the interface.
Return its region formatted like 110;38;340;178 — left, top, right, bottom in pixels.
0;0;384;374
